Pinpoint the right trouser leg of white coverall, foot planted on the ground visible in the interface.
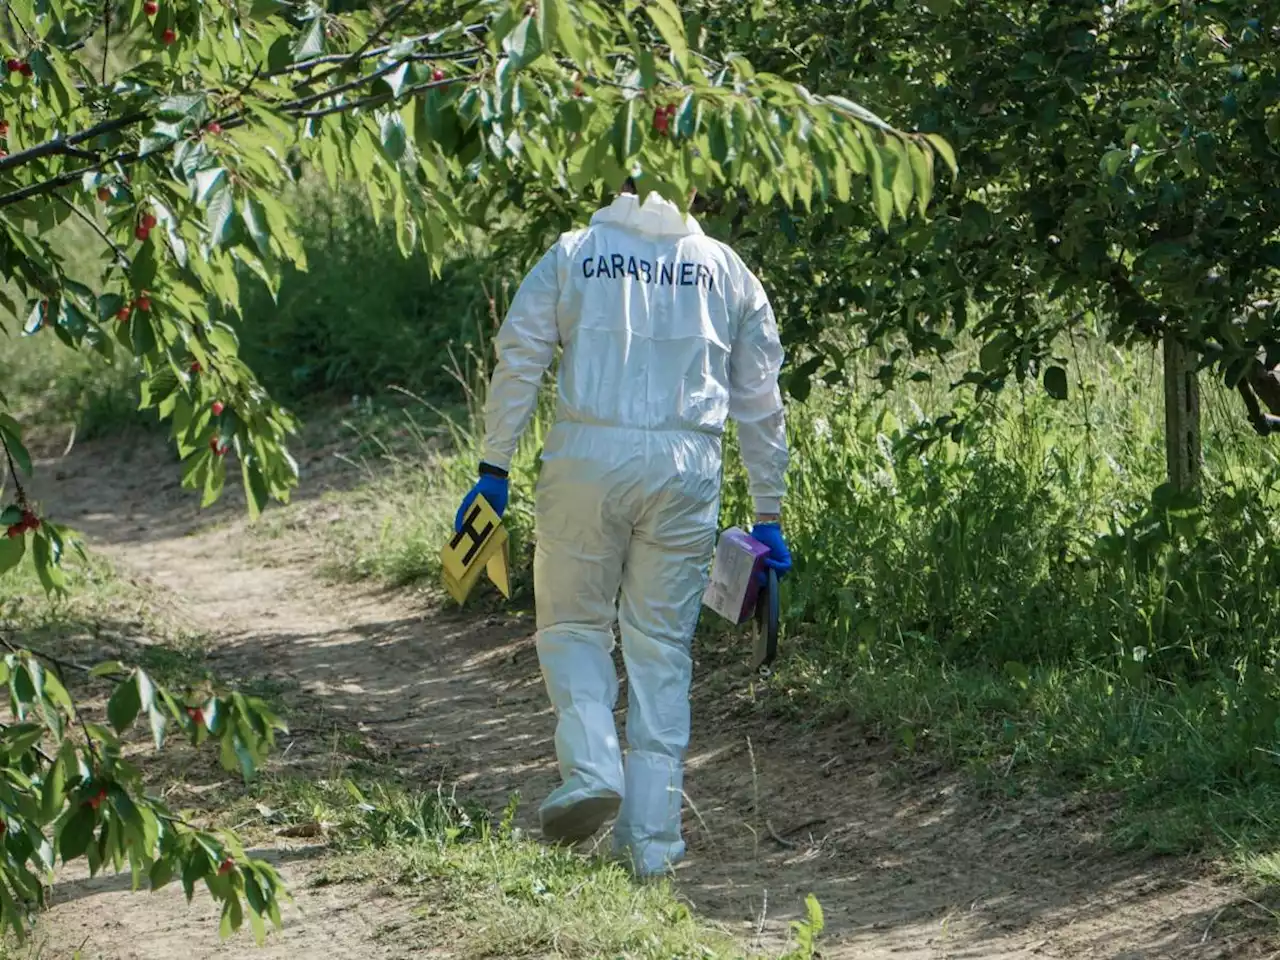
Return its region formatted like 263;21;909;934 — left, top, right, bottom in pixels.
614;493;718;877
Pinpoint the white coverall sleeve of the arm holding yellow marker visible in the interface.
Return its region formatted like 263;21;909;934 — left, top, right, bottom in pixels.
481;247;559;470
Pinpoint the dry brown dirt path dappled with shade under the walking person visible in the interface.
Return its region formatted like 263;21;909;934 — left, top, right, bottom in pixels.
22;435;1276;960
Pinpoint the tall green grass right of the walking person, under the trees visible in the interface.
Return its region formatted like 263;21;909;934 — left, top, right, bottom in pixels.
726;335;1280;867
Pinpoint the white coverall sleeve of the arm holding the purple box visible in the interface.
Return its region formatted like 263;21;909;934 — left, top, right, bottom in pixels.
728;274;790;513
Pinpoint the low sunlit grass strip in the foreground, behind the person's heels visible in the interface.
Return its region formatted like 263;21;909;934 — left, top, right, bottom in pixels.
224;777;820;960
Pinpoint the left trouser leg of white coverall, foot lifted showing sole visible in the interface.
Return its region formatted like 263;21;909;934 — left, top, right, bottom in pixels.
534;461;630;842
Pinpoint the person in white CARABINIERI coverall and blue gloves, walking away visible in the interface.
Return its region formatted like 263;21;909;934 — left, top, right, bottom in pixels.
457;184;791;877
